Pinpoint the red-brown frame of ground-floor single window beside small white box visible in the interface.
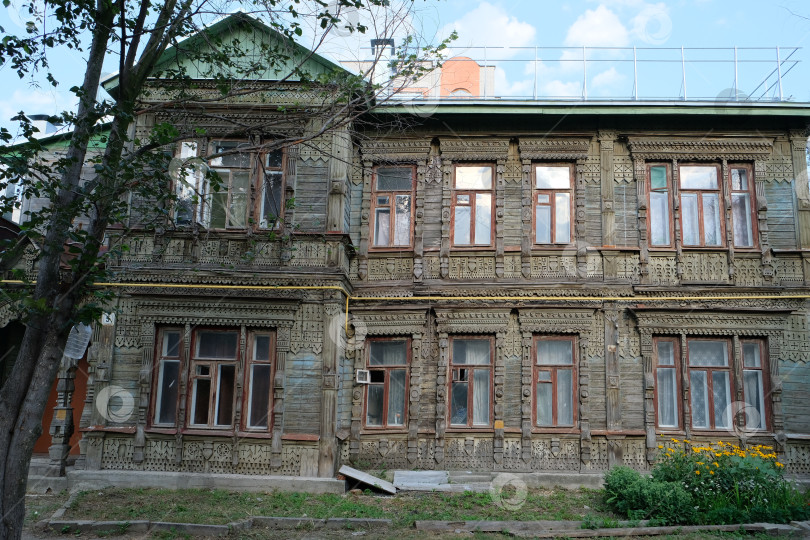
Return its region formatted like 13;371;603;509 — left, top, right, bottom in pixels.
363;336;412;431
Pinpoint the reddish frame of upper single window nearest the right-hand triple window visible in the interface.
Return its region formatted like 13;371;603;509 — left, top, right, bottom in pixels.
532;163;576;247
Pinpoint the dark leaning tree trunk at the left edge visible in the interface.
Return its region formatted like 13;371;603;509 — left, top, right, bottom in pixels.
0;0;114;540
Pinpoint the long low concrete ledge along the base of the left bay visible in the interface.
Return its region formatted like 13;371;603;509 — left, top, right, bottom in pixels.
67;470;346;494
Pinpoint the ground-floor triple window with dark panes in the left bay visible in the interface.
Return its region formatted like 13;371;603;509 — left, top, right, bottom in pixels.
152;328;275;432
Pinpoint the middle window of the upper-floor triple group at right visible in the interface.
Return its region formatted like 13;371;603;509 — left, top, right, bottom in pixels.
679;165;723;246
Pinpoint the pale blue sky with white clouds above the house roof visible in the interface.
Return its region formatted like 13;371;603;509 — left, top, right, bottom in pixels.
0;0;810;134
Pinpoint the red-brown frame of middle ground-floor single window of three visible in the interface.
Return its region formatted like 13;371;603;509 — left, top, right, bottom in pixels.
447;335;495;431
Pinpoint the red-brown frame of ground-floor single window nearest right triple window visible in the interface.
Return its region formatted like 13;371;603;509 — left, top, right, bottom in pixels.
532;335;579;432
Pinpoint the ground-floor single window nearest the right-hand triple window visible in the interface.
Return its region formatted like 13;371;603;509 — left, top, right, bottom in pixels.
534;336;576;427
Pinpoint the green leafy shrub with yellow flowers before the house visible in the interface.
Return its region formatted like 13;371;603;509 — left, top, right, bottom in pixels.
605;439;810;524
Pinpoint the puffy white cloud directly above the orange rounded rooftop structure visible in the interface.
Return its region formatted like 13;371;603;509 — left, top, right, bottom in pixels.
439;2;537;57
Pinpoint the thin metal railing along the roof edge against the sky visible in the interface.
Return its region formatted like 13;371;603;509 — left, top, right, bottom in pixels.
370;47;806;102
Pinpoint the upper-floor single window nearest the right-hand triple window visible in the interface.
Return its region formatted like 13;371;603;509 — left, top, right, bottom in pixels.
534;165;573;244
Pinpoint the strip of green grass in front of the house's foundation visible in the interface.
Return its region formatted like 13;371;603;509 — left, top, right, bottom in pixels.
64;488;616;528
